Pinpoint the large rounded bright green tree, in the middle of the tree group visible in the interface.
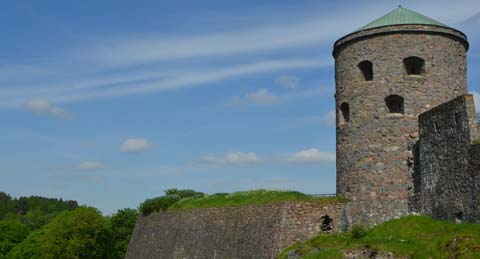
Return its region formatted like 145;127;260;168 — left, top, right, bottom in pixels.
40;207;108;259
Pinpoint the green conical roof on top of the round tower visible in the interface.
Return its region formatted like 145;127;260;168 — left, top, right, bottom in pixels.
357;6;450;31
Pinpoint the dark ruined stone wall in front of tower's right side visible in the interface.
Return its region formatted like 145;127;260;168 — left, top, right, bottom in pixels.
415;95;480;222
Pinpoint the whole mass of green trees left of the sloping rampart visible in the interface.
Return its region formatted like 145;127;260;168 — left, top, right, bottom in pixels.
0;192;138;259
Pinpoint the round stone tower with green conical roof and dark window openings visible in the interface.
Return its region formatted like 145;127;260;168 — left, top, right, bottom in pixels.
333;7;468;223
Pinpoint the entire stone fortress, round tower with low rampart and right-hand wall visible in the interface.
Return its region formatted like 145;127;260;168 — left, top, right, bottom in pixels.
126;7;480;259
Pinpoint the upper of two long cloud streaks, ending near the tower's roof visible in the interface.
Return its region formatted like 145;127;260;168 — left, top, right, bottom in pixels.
84;18;348;66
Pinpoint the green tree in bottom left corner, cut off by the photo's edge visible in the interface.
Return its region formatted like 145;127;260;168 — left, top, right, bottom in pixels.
0;220;29;256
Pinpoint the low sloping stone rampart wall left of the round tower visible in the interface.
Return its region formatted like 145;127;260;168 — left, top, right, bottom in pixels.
126;202;344;259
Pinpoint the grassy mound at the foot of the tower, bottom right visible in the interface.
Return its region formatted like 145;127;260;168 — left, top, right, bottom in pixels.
280;216;480;259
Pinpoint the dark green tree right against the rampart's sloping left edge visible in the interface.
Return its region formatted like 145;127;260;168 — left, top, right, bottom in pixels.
109;209;138;258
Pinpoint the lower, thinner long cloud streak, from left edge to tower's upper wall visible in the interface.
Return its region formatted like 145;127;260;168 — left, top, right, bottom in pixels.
0;59;332;108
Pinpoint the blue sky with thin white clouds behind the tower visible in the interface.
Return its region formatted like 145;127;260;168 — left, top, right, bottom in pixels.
0;0;480;213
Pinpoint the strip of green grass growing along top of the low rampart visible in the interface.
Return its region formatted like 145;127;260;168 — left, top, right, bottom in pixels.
168;190;346;210
